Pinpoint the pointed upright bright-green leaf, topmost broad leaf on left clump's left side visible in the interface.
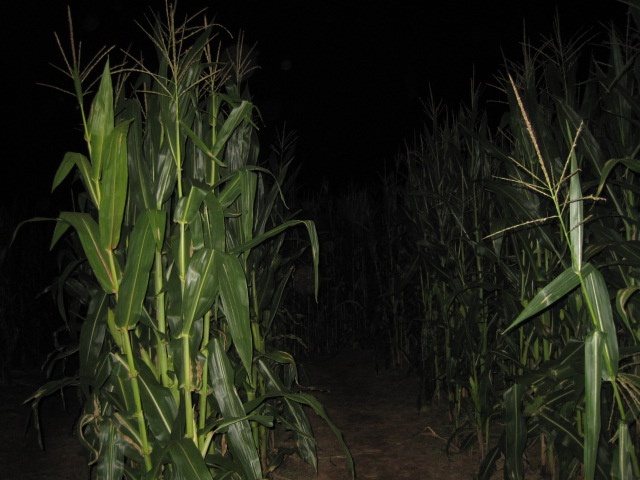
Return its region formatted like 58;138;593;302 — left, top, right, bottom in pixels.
87;60;114;186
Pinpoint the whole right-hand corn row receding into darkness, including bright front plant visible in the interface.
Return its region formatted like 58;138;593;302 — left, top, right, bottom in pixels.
294;6;640;479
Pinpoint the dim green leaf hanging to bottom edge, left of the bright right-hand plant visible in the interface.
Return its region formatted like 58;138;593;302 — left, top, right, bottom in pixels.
504;383;527;480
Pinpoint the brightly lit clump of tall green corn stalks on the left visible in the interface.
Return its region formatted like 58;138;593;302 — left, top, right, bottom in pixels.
25;5;353;479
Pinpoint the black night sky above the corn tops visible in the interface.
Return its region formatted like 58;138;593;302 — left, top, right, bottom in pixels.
0;0;626;208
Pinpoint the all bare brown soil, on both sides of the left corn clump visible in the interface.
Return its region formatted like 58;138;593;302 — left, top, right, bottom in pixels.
0;351;492;480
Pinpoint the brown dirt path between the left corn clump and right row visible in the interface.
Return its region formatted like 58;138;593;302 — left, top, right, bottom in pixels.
274;351;478;480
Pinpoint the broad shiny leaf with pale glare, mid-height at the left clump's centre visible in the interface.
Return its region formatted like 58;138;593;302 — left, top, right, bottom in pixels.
182;248;220;335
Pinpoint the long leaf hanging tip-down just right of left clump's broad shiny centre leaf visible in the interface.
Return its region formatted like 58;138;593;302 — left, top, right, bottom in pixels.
216;252;253;375
